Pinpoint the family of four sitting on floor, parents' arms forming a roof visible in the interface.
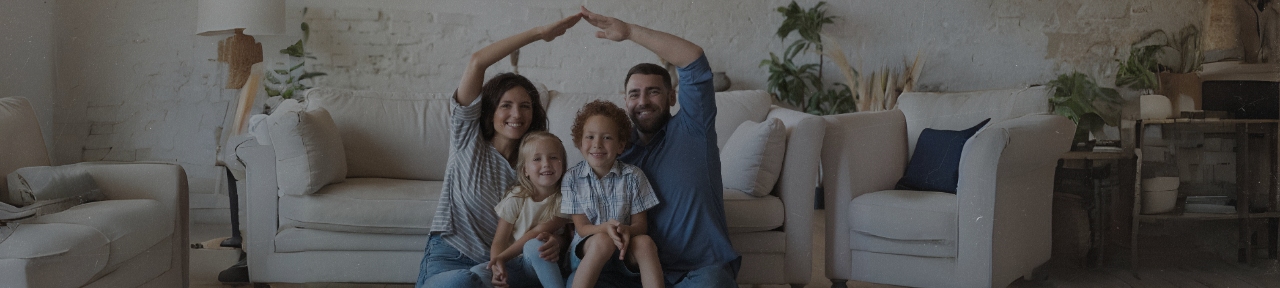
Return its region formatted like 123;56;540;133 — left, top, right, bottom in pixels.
417;8;741;288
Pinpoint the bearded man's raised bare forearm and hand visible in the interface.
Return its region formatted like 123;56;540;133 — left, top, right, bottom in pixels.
582;6;703;67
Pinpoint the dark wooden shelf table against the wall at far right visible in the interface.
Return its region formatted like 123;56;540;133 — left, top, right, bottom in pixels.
1129;119;1280;266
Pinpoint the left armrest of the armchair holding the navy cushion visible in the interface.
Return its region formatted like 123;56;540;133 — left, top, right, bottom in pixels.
822;110;906;279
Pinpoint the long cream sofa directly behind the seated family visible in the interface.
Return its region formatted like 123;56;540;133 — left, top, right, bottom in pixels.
236;88;826;285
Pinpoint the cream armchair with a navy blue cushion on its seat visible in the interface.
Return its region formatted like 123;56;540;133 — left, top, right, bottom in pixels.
822;87;1075;287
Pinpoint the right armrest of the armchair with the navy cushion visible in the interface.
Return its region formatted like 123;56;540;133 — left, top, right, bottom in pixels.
956;114;1075;279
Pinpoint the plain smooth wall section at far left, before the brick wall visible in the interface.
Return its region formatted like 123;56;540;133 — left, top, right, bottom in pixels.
0;0;54;155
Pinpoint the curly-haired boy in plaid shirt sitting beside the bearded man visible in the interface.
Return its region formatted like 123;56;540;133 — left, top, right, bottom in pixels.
561;100;663;288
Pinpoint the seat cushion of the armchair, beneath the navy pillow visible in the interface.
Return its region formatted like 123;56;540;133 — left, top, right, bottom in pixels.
849;189;959;257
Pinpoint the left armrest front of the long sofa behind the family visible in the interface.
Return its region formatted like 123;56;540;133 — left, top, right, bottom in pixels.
236;142;279;275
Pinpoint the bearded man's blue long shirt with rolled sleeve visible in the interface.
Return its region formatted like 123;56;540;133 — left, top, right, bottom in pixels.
618;55;741;279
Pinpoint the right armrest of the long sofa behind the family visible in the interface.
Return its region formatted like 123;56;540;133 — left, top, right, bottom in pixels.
768;106;827;283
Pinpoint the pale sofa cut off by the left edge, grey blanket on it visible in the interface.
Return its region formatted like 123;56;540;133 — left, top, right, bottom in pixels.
0;97;188;288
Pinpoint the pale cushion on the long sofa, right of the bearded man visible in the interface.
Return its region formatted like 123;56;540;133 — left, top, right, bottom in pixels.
721;118;787;197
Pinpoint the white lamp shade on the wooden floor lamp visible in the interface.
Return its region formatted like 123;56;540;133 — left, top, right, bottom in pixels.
196;0;284;36
